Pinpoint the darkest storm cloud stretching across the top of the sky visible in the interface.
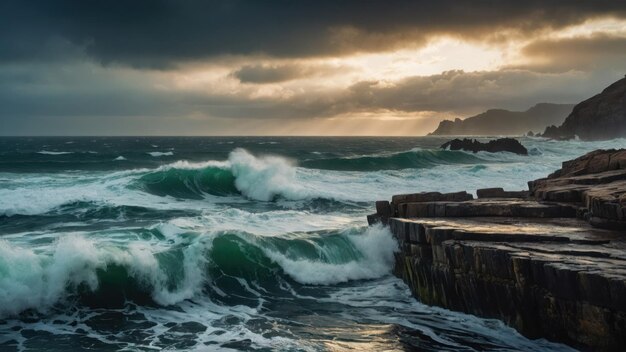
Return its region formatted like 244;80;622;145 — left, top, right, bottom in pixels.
0;0;625;68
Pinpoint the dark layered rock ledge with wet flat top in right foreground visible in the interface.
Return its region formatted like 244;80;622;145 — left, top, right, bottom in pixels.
368;150;626;351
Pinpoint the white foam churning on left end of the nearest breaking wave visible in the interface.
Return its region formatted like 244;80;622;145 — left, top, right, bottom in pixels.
0;234;211;317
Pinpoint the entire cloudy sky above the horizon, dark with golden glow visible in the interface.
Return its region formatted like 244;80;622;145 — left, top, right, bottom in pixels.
0;0;626;136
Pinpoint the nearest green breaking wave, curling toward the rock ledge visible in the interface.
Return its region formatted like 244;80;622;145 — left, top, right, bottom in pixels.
0;227;397;317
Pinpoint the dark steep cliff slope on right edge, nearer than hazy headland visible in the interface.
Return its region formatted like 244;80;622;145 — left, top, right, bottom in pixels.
543;78;626;140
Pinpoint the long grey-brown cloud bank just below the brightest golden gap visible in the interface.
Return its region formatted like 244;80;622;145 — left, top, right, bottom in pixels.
266;70;620;117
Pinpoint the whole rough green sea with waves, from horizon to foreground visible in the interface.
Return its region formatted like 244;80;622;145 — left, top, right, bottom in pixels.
0;137;626;351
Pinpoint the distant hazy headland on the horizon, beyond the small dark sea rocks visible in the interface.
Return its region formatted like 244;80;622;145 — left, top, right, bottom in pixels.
430;103;574;136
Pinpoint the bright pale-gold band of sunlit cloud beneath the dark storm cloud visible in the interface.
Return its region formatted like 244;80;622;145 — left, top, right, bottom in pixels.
171;18;626;98
